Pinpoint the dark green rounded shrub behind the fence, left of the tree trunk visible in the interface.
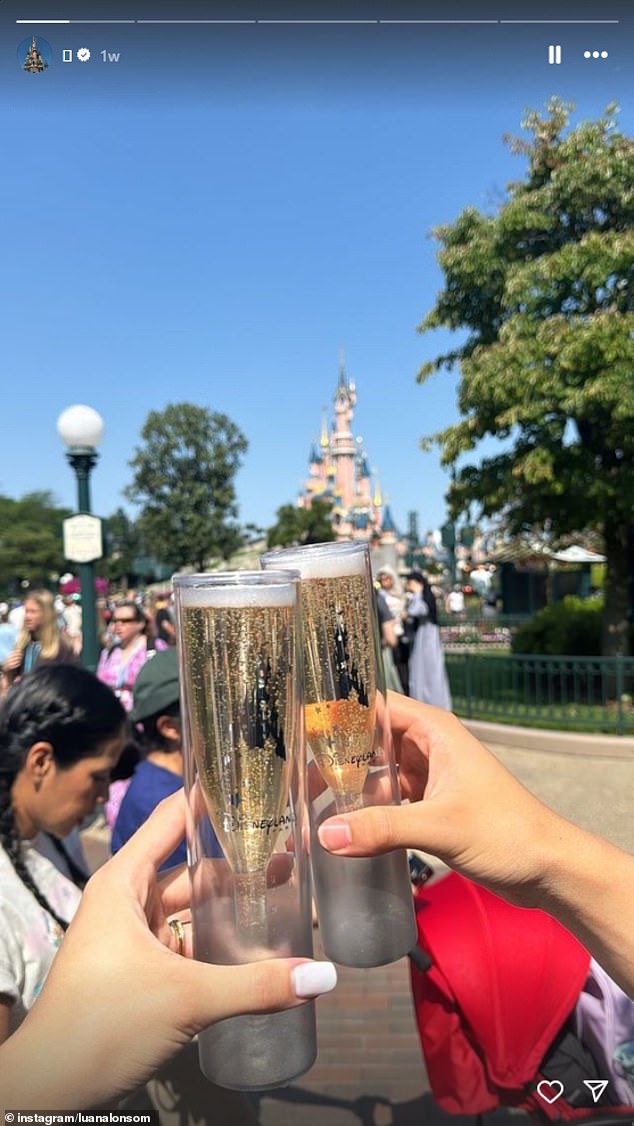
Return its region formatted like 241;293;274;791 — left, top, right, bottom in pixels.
511;595;604;656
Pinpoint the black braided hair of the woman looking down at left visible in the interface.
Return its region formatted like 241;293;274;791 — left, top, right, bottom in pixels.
0;664;125;930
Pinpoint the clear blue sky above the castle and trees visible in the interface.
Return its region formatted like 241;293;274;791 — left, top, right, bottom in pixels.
0;7;634;530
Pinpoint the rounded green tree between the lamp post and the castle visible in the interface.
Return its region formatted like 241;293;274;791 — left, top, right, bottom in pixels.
125;403;248;569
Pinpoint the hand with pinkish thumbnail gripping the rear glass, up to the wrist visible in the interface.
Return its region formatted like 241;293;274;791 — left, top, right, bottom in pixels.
319;692;564;906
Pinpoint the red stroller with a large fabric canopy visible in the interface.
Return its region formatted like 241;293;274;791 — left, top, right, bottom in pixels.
410;873;633;1126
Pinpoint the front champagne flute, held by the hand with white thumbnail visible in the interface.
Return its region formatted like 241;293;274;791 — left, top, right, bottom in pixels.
173;571;316;1090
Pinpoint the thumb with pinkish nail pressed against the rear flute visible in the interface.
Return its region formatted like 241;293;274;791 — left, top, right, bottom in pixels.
318;802;439;856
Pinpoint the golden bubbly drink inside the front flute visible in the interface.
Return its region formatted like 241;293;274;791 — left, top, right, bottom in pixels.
181;606;296;946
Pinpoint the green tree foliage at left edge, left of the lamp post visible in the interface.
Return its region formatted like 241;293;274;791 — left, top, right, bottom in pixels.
0;491;71;593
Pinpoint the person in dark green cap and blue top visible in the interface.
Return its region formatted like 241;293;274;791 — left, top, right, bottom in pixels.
110;649;222;869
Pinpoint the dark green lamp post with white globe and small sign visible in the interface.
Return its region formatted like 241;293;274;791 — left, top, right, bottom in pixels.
57;404;104;671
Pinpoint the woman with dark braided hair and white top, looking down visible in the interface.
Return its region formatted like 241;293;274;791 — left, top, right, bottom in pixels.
0;664;126;1043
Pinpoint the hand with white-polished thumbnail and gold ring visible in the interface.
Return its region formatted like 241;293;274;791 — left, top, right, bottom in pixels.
6;790;336;1109
